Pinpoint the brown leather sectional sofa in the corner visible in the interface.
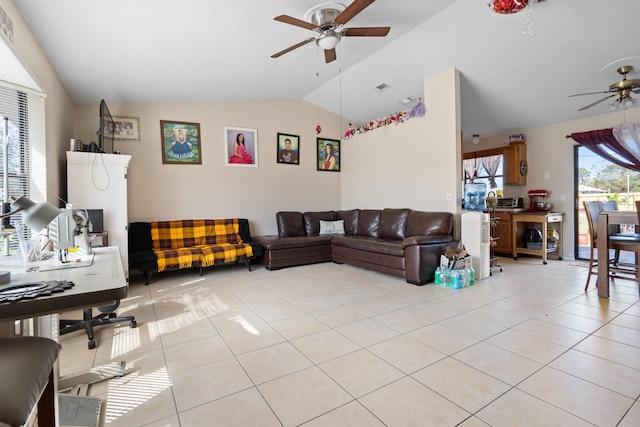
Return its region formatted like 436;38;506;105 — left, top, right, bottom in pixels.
253;209;457;285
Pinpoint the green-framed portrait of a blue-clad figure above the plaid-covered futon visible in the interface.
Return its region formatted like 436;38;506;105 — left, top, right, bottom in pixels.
160;120;202;165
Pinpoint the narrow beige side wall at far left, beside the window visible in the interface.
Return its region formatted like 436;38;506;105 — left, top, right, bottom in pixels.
0;0;74;205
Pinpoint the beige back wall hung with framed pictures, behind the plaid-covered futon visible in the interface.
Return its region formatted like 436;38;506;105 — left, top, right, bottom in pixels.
71;100;347;235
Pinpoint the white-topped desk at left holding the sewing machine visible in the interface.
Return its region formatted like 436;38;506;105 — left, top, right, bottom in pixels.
0;246;129;322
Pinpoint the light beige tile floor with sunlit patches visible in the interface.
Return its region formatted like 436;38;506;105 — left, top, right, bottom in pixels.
60;257;640;427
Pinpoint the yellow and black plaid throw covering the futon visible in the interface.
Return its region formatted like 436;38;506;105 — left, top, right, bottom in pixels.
151;218;253;272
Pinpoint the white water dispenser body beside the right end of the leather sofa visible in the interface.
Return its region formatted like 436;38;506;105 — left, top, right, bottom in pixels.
460;212;491;279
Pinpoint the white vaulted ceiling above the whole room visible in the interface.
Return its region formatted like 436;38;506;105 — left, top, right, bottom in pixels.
15;0;640;136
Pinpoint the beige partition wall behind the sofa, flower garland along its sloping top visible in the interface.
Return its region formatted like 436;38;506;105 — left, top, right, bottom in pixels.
341;69;461;217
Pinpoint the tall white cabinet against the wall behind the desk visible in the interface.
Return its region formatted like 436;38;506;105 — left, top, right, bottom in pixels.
67;151;131;277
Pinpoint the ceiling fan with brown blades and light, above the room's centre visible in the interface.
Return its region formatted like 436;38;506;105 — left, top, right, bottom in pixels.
271;0;390;64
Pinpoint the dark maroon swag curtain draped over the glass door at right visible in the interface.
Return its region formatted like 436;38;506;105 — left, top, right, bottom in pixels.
571;128;640;172
